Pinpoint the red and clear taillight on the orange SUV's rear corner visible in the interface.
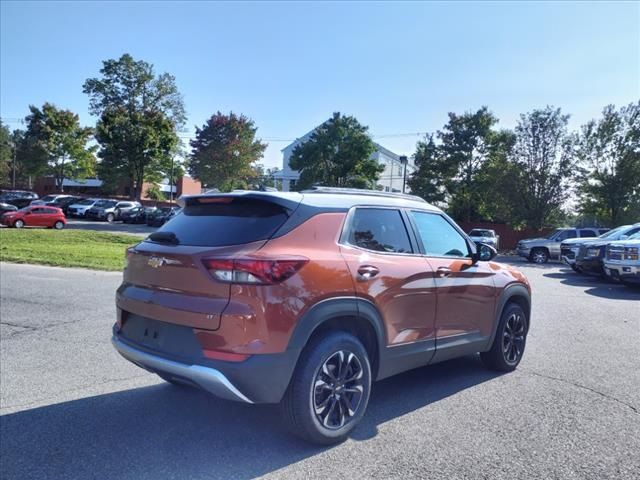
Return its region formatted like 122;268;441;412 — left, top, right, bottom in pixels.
202;257;309;285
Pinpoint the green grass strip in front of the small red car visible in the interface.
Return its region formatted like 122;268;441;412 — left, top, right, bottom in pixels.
0;228;141;271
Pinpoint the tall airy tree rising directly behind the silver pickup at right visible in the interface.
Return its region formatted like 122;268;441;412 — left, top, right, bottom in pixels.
511;106;575;229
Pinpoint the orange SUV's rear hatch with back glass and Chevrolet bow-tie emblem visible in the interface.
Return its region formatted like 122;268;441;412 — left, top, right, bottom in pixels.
118;193;298;330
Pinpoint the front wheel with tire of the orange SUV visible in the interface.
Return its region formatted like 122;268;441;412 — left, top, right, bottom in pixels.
480;303;529;372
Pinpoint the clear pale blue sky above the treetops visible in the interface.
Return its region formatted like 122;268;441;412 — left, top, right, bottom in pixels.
0;1;640;167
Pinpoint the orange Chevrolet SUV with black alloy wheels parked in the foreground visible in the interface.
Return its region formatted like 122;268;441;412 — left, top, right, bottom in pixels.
112;188;531;444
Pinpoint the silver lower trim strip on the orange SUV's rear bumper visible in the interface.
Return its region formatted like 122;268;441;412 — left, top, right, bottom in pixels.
111;336;253;403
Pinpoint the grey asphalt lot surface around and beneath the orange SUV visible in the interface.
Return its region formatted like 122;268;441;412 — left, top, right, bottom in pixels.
0;264;640;480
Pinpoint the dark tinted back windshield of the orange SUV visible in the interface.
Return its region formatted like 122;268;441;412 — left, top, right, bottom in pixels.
158;197;288;247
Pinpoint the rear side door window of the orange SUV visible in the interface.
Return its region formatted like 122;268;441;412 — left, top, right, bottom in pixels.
348;208;413;253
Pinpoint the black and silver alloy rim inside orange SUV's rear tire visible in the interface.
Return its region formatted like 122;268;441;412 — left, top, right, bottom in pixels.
312;350;364;430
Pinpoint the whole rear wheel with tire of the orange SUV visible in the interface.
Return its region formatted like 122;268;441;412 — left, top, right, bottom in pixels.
281;332;371;445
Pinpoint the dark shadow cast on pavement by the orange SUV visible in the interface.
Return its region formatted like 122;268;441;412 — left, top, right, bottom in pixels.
0;356;497;479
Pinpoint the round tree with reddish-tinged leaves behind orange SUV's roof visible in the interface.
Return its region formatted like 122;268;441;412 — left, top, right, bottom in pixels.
188;112;267;191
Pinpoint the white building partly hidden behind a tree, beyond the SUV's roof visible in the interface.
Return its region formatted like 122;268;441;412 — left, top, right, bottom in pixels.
273;124;415;192
